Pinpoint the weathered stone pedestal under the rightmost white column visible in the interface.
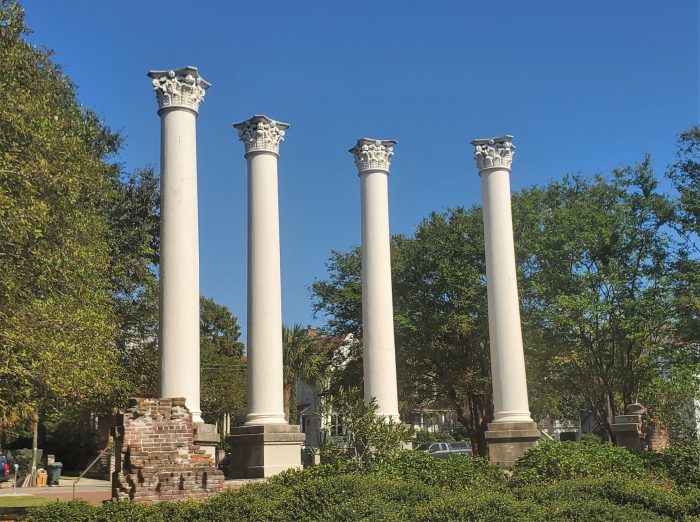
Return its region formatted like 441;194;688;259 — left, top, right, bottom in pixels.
486;421;541;469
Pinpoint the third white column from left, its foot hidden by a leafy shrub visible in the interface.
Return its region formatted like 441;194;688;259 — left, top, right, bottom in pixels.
350;138;399;420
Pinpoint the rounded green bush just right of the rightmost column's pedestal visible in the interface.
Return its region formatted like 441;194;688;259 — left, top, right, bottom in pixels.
512;441;650;485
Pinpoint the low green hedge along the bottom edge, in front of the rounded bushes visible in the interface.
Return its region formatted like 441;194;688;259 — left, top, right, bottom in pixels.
29;468;700;522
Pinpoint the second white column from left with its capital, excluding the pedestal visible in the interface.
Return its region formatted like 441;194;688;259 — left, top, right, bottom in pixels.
233;116;289;426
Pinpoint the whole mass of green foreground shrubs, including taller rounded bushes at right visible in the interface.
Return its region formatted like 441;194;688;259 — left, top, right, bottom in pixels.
29;436;700;522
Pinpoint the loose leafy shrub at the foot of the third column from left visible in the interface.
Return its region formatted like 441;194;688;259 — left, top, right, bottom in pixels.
321;388;412;469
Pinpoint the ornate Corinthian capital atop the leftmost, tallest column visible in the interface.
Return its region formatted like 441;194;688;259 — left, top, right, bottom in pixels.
148;66;211;112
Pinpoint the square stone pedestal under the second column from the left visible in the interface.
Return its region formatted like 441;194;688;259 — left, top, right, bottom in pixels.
226;424;306;479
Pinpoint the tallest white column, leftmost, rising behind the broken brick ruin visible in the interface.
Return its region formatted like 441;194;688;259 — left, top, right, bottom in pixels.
148;67;211;423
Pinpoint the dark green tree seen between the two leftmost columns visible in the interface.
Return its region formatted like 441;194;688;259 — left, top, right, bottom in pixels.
199;297;246;423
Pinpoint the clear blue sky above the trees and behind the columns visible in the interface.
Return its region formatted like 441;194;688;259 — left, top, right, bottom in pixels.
24;0;700;340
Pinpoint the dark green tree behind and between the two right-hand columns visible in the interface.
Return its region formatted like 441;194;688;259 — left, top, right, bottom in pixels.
312;213;492;455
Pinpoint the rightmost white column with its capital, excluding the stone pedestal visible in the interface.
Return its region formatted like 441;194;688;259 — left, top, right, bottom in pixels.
472;136;532;422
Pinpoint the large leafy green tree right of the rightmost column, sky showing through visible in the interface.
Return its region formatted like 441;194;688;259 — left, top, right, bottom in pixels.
514;158;692;439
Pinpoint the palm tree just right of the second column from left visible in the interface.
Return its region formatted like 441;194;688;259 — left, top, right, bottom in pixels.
282;324;327;422
